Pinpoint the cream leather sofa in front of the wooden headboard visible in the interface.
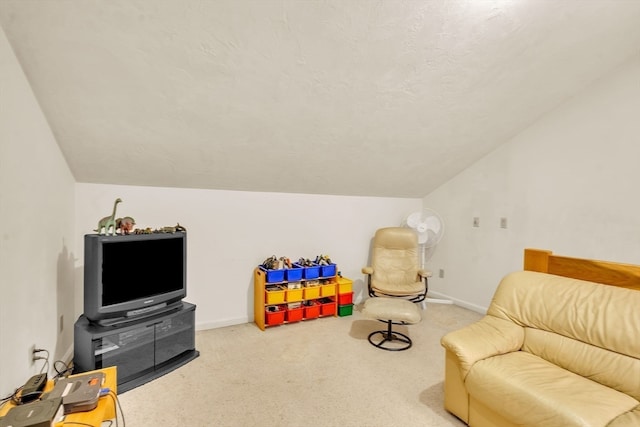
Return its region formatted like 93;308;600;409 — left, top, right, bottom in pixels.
441;271;640;427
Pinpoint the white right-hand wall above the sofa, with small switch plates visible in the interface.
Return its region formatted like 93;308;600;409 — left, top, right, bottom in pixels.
424;56;640;311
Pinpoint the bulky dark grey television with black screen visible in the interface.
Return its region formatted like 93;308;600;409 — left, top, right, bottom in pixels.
84;232;187;324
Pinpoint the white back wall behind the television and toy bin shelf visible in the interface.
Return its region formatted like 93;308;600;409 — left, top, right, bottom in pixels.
76;183;422;329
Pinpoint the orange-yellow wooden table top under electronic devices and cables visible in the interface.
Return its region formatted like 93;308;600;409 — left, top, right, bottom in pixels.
0;366;118;427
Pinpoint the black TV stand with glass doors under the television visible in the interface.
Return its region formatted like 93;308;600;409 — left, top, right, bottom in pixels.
73;301;199;393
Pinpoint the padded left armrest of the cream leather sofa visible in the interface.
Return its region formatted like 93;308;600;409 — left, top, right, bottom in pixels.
440;316;524;378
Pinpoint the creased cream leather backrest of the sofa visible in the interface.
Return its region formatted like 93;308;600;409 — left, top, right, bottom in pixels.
487;271;640;400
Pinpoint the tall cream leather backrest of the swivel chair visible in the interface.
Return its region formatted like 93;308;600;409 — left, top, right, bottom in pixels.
371;227;420;289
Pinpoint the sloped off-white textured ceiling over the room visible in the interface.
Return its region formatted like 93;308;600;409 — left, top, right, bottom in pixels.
0;0;640;197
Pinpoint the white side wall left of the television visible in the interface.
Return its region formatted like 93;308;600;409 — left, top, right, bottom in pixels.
0;28;75;397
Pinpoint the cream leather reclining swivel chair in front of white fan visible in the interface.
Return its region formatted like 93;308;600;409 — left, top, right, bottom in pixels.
362;227;431;302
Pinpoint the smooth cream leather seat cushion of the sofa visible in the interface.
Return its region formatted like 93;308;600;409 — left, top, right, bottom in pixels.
465;351;640;427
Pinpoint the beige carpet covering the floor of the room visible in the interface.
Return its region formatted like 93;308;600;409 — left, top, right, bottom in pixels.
120;303;481;427
